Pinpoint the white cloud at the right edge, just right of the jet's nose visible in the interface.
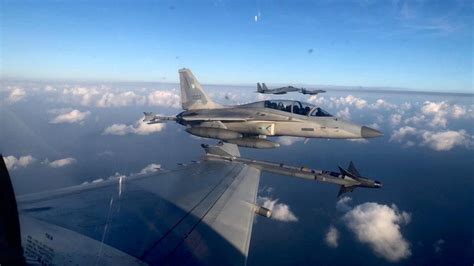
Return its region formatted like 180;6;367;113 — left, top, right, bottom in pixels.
421;130;473;151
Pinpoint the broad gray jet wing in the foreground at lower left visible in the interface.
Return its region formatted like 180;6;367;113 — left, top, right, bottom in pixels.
17;158;260;265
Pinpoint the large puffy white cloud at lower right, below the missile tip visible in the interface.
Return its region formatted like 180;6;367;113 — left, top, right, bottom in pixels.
343;202;411;262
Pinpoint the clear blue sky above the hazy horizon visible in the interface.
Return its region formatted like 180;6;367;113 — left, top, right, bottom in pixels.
1;1;474;92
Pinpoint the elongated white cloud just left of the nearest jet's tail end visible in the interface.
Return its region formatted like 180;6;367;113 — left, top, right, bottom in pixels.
102;118;166;136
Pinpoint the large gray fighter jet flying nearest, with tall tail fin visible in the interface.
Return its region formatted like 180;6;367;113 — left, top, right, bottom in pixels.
144;69;382;149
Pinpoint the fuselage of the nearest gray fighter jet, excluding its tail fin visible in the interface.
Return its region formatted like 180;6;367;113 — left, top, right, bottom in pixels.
177;101;381;138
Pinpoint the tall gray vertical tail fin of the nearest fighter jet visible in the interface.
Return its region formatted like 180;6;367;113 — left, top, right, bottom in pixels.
179;68;221;110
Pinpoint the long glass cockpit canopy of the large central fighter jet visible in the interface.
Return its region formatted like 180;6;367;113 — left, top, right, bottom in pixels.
243;100;332;116
